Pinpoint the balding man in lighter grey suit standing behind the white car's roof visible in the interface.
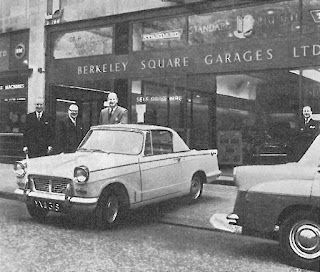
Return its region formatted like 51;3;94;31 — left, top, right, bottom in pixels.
99;92;128;125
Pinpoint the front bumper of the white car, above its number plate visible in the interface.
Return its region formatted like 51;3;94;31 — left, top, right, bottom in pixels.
14;188;99;212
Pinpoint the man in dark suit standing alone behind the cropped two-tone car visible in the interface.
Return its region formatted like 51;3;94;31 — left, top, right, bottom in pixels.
298;106;319;157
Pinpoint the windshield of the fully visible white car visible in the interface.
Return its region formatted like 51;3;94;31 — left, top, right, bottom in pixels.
78;130;143;155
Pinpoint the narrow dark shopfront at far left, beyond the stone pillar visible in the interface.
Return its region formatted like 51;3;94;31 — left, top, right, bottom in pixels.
0;30;31;161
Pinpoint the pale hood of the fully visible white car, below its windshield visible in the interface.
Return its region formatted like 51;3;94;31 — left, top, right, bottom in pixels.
27;151;137;178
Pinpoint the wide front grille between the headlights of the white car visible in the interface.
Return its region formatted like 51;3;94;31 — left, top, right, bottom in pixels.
29;176;70;194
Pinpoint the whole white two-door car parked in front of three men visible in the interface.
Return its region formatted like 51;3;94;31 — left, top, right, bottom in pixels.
14;125;220;228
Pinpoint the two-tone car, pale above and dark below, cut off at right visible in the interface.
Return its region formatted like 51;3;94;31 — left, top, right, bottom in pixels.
227;136;320;267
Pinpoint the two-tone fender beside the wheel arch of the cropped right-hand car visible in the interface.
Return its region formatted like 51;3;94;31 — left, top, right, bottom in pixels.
245;179;313;232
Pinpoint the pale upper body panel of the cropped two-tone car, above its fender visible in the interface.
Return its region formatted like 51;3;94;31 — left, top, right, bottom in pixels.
234;163;317;191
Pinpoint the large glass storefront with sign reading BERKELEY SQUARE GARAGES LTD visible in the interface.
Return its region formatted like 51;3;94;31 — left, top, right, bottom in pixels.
46;0;320;165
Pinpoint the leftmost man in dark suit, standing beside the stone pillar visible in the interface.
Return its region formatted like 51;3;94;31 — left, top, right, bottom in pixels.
23;98;54;158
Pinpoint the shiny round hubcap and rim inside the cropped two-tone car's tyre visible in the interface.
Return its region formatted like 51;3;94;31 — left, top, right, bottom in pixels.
289;221;320;260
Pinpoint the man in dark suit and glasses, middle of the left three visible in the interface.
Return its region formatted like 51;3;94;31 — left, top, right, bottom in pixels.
57;104;83;153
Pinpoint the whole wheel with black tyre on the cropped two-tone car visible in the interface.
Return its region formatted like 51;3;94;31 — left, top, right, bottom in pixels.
280;211;320;267
